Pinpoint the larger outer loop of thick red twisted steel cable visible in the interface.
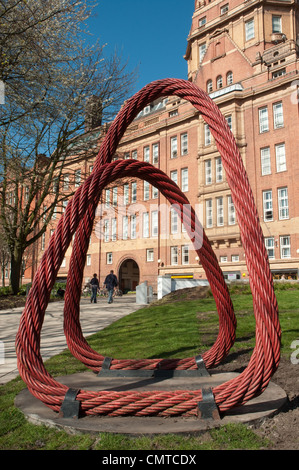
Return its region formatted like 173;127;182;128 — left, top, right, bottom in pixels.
16;79;281;416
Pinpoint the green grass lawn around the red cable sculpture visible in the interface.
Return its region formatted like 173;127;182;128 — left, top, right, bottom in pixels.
0;288;299;450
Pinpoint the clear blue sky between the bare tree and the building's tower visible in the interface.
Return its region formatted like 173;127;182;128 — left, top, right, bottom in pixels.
88;0;194;93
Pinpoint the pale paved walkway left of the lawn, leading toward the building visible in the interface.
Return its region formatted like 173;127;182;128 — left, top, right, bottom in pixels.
0;295;142;385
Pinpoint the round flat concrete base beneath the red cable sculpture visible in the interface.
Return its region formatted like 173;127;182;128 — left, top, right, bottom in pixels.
15;371;287;436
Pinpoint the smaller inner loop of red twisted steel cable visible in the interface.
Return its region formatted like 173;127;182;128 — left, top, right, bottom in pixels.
64;160;236;372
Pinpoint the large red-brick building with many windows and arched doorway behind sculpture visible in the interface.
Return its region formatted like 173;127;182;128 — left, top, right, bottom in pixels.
21;0;299;290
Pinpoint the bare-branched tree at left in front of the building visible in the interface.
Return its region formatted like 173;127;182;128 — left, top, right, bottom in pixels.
0;0;135;293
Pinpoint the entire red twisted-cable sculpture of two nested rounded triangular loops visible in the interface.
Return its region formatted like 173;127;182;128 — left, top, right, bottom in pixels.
16;79;281;416
